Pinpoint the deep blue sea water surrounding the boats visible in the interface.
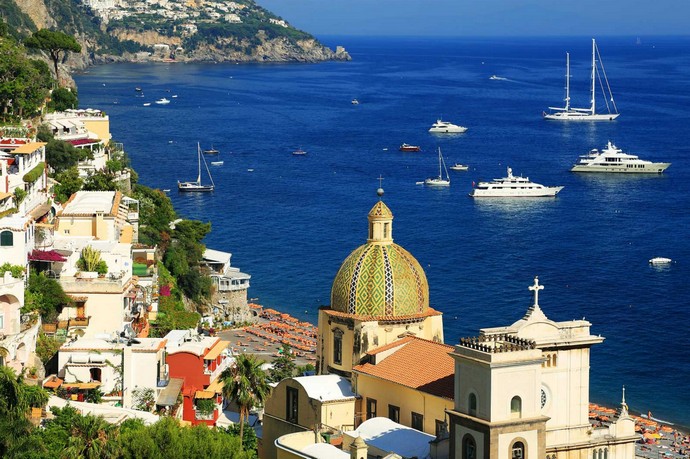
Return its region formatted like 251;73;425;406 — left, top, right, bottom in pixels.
76;37;690;425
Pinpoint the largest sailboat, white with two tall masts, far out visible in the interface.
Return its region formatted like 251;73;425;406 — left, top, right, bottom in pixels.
543;38;620;121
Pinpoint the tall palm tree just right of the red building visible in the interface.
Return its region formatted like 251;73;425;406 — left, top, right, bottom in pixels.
220;354;271;447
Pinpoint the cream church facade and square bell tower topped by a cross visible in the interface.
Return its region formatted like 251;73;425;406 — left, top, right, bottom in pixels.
448;278;637;459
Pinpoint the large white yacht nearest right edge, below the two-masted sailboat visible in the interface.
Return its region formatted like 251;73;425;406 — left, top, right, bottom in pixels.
570;141;671;174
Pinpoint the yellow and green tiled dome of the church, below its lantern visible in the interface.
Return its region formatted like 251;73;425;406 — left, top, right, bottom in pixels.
331;244;429;317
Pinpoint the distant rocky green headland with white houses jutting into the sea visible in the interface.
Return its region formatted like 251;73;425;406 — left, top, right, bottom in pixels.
0;0;350;68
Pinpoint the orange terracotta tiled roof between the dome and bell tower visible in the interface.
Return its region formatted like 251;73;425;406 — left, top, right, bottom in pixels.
353;337;455;400
